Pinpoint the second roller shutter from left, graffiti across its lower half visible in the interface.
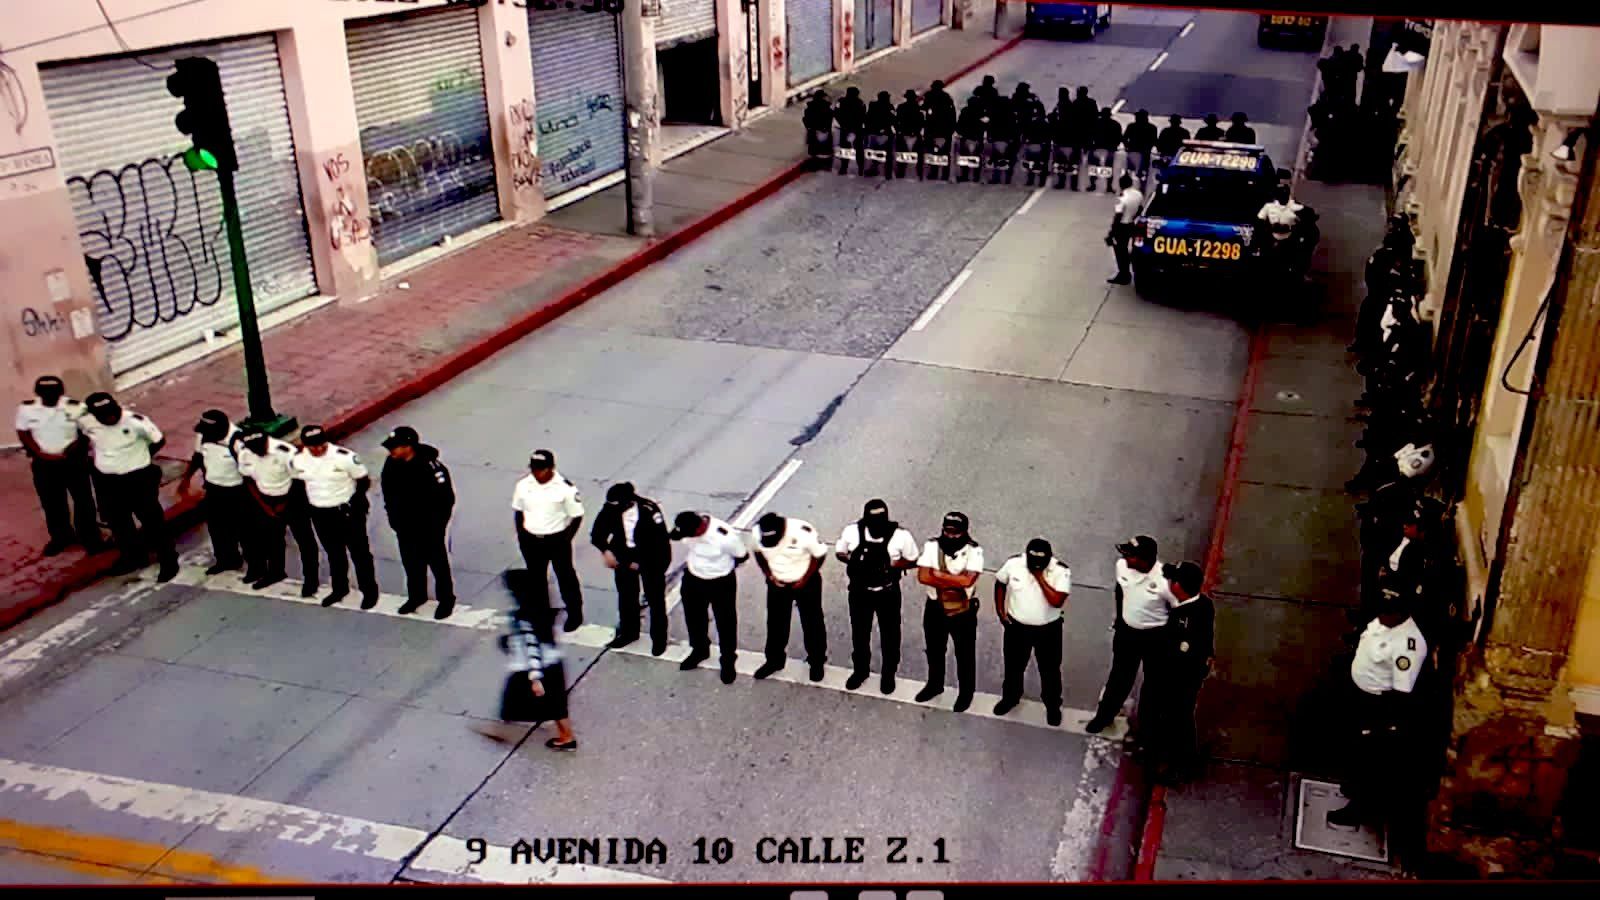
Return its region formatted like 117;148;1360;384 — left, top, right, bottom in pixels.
344;8;499;266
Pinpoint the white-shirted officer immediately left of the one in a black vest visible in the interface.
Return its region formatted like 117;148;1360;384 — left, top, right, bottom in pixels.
755;512;827;681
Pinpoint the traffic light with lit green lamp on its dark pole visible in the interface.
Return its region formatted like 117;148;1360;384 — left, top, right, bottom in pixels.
166;56;299;437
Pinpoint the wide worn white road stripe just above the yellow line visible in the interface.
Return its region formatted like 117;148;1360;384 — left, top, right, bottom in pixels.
0;759;662;884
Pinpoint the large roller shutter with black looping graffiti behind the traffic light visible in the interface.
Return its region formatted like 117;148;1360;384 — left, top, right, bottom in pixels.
40;35;317;375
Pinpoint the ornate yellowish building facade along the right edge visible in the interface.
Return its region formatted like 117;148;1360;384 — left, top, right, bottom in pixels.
1394;15;1600;874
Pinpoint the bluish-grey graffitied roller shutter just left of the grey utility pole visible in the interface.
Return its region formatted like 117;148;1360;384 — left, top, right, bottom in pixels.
528;6;626;197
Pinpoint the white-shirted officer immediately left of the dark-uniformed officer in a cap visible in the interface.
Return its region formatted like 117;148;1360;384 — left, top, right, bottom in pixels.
290;424;378;610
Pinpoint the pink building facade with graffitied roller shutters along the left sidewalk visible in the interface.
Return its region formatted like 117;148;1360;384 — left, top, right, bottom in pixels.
0;0;971;416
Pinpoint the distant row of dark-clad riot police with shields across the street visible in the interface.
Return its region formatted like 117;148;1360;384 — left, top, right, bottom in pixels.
802;75;1256;194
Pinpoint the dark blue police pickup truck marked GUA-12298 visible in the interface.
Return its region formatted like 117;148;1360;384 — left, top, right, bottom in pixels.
1133;141;1288;293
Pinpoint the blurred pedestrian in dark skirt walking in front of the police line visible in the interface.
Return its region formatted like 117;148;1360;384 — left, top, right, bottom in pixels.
478;569;578;751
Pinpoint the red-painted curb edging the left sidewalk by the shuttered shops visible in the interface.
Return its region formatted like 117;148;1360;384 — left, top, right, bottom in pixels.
0;35;1022;631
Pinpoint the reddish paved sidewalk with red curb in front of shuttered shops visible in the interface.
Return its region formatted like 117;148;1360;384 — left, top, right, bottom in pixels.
0;19;1019;628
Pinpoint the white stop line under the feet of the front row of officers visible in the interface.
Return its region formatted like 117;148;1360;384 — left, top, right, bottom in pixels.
128;566;1126;740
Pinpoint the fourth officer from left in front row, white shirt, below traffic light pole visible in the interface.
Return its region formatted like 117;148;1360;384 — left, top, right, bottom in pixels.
234;429;318;599
